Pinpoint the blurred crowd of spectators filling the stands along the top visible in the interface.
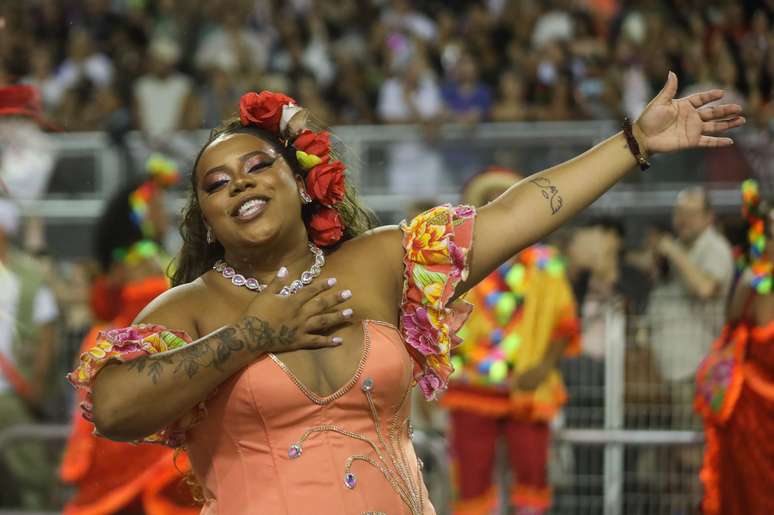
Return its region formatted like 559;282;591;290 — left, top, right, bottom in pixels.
0;0;774;138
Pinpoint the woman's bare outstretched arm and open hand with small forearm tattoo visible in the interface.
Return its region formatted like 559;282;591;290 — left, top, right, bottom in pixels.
458;72;745;293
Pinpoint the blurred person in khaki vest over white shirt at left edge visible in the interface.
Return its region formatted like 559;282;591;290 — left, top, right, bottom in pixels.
0;198;59;511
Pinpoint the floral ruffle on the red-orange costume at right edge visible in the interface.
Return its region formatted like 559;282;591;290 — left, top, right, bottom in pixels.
694;324;750;424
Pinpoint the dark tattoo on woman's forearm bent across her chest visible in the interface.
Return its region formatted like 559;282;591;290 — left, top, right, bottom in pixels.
128;317;296;384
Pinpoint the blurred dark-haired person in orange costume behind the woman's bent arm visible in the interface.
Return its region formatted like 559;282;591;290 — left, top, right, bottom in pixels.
59;155;199;515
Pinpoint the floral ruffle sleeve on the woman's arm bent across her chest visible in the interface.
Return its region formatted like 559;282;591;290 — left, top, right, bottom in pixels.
67;324;205;447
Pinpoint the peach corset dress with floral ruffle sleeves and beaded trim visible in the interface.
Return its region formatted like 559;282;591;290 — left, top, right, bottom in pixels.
69;205;475;515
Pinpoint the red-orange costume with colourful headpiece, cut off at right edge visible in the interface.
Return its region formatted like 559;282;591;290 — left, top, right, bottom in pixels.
695;181;774;515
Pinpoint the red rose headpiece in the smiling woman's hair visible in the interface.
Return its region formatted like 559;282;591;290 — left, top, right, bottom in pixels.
239;91;346;247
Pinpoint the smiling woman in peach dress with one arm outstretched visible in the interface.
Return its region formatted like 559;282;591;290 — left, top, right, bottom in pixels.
70;78;744;515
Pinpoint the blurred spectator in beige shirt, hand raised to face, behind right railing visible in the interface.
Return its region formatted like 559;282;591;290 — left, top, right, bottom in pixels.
644;188;734;509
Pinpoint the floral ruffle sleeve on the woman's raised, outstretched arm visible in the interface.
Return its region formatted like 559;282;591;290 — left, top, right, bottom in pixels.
400;204;476;399
